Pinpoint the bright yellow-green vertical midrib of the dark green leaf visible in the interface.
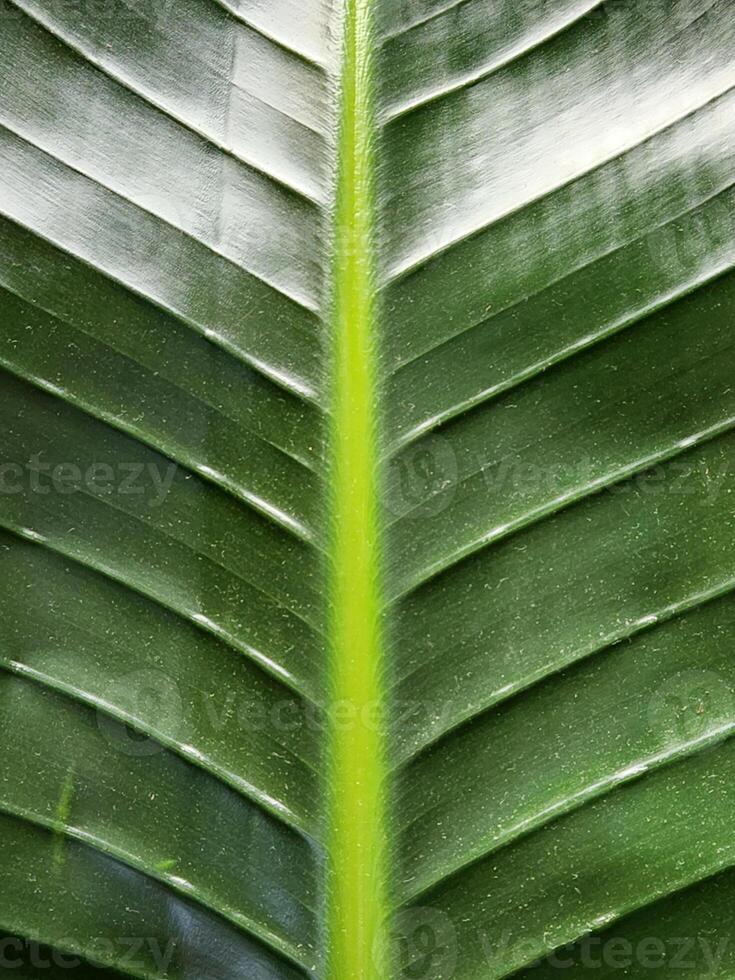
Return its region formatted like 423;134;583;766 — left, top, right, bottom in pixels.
327;0;388;980
